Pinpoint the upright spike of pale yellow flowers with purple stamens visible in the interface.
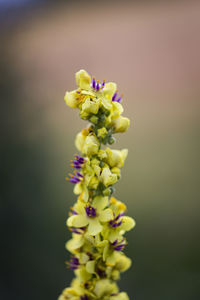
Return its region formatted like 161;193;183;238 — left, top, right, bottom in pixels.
59;70;135;300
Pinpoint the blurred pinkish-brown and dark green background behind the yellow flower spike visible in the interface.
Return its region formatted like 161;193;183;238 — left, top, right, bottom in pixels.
0;0;200;300
